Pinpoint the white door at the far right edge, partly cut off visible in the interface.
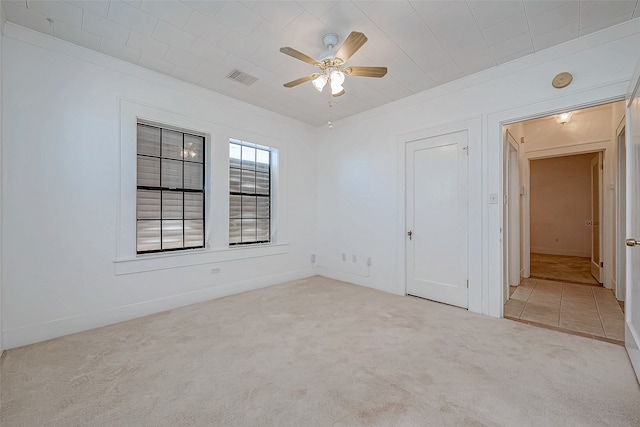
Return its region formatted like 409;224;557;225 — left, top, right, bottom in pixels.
624;75;640;378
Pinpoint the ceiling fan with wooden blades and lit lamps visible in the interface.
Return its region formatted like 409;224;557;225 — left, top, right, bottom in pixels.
280;31;387;96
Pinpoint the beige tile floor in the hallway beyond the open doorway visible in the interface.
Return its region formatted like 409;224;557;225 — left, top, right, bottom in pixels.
504;278;624;345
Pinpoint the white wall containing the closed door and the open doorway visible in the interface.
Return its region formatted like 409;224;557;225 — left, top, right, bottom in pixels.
318;20;640;316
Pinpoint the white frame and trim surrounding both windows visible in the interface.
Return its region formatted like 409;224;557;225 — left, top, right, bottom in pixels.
113;99;289;275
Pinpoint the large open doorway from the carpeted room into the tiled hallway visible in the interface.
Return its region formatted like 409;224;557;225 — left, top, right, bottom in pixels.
503;101;625;343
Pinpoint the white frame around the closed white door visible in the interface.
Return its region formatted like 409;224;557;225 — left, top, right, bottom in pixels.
396;116;480;313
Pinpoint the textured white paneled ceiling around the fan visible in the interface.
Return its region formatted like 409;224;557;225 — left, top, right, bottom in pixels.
2;0;640;125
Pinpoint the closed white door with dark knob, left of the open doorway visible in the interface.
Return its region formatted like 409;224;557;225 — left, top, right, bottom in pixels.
406;131;469;308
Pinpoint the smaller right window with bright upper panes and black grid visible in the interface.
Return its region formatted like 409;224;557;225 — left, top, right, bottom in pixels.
229;140;271;245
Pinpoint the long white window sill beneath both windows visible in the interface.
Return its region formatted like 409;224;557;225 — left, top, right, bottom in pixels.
114;243;289;276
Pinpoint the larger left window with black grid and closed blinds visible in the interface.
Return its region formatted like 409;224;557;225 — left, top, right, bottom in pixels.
136;123;205;254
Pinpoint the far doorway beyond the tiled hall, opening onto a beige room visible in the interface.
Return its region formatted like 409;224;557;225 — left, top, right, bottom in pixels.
528;152;602;285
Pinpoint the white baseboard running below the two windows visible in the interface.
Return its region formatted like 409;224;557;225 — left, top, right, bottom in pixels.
2;268;318;350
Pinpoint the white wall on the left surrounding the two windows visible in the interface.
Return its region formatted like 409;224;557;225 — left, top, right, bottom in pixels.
2;24;317;348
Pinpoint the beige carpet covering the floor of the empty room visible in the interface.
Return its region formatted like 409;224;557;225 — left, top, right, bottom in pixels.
0;277;640;427
